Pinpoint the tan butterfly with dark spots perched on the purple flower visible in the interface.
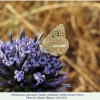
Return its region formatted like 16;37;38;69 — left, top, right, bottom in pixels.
40;24;69;56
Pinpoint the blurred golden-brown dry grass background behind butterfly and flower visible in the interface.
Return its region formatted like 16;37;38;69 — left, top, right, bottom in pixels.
0;1;100;92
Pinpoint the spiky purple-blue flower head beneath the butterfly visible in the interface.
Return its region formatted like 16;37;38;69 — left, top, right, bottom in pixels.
0;29;68;92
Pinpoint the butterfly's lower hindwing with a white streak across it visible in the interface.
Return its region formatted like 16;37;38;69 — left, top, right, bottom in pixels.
43;37;69;55
